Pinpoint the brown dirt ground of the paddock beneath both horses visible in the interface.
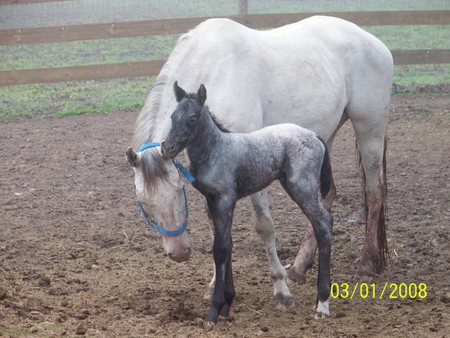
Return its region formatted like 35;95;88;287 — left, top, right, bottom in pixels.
0;94;450;338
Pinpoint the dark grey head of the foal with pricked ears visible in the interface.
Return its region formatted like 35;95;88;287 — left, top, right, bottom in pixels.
161;82;206;158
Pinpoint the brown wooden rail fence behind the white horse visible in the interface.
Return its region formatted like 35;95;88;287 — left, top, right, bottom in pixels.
0;6;450;86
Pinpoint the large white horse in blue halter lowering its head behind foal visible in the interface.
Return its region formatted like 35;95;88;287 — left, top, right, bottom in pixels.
127;16;393;308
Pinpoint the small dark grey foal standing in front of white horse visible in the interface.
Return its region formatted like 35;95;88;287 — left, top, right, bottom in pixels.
162;82;333;322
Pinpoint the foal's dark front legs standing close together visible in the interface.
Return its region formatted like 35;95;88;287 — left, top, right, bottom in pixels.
205;196;236;323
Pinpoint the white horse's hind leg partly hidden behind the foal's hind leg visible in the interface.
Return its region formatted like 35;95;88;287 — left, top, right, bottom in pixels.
288;180;336;283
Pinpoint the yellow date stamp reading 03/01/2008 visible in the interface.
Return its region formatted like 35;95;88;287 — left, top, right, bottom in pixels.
331;282;428;299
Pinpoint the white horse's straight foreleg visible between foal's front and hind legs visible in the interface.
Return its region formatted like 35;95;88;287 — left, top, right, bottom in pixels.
251;189;294;309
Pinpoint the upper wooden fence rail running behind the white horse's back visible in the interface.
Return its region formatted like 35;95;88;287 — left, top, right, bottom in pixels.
0;10;450;45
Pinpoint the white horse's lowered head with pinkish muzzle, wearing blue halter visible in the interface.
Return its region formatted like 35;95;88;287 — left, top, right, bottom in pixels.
126;146;191;262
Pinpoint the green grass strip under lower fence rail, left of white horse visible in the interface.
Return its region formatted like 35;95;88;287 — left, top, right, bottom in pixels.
0;77;154;121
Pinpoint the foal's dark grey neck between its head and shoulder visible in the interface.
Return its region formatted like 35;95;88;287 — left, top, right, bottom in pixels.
187;107;228;164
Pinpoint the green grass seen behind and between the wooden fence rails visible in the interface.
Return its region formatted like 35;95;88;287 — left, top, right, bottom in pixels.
0;0;450;121
